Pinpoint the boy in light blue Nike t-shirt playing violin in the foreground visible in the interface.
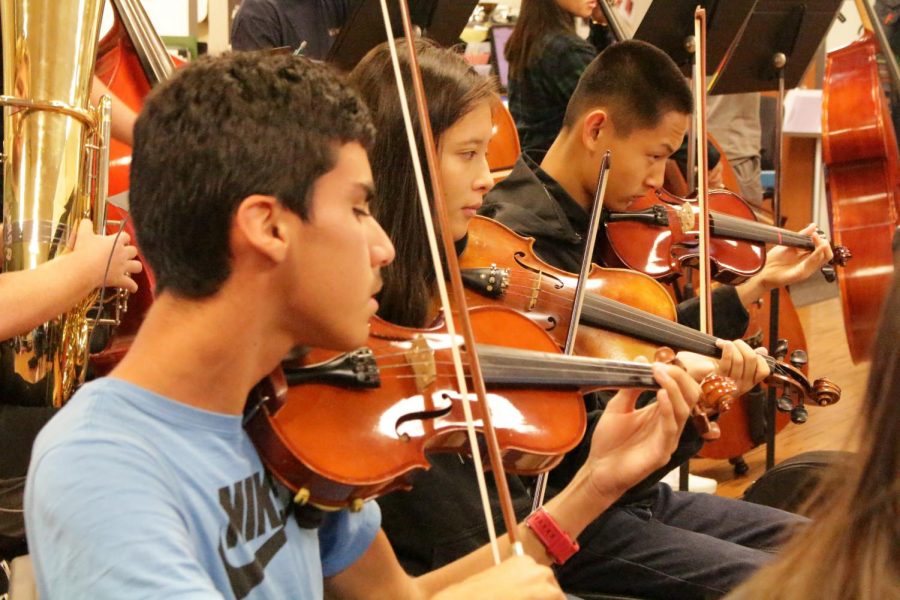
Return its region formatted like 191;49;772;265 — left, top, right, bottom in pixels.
26;54;712;600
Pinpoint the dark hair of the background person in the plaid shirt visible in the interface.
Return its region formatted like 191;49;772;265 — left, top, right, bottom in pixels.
504;0;575;77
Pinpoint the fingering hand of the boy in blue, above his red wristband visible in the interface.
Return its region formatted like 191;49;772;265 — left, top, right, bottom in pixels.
585;363;700;497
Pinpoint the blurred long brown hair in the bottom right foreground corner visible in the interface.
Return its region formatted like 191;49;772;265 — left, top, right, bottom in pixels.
737;268;900;600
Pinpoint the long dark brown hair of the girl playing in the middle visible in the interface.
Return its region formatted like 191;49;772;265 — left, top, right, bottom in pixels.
349;39;497;327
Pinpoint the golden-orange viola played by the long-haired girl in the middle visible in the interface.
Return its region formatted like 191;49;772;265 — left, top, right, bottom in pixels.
460;216;841;406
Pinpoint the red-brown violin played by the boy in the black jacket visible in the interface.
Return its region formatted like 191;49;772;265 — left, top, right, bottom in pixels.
598;189;851;284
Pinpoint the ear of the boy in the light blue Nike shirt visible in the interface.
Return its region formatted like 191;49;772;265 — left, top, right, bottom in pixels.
232;194;288;263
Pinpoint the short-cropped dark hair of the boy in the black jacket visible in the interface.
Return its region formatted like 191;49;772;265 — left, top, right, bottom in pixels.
563;40;694;135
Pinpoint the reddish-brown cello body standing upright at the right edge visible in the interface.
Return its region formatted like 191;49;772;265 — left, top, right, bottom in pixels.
822;35;900;362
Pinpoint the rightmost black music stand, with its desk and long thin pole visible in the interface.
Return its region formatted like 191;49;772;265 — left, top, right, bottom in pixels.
710;0;842;470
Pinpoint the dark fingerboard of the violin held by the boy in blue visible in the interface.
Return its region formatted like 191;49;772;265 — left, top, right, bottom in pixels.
478;344;659;391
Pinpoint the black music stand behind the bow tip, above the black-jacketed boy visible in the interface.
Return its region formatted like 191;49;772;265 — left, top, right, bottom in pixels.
634;0;758;77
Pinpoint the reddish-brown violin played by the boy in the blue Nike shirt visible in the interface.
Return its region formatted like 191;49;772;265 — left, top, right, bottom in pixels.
244;307;736;509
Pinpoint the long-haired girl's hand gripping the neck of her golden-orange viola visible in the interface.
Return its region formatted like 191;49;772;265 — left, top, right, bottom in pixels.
677;340;769;395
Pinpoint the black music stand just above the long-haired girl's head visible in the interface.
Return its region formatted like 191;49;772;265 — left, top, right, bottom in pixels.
325;0;478;71
